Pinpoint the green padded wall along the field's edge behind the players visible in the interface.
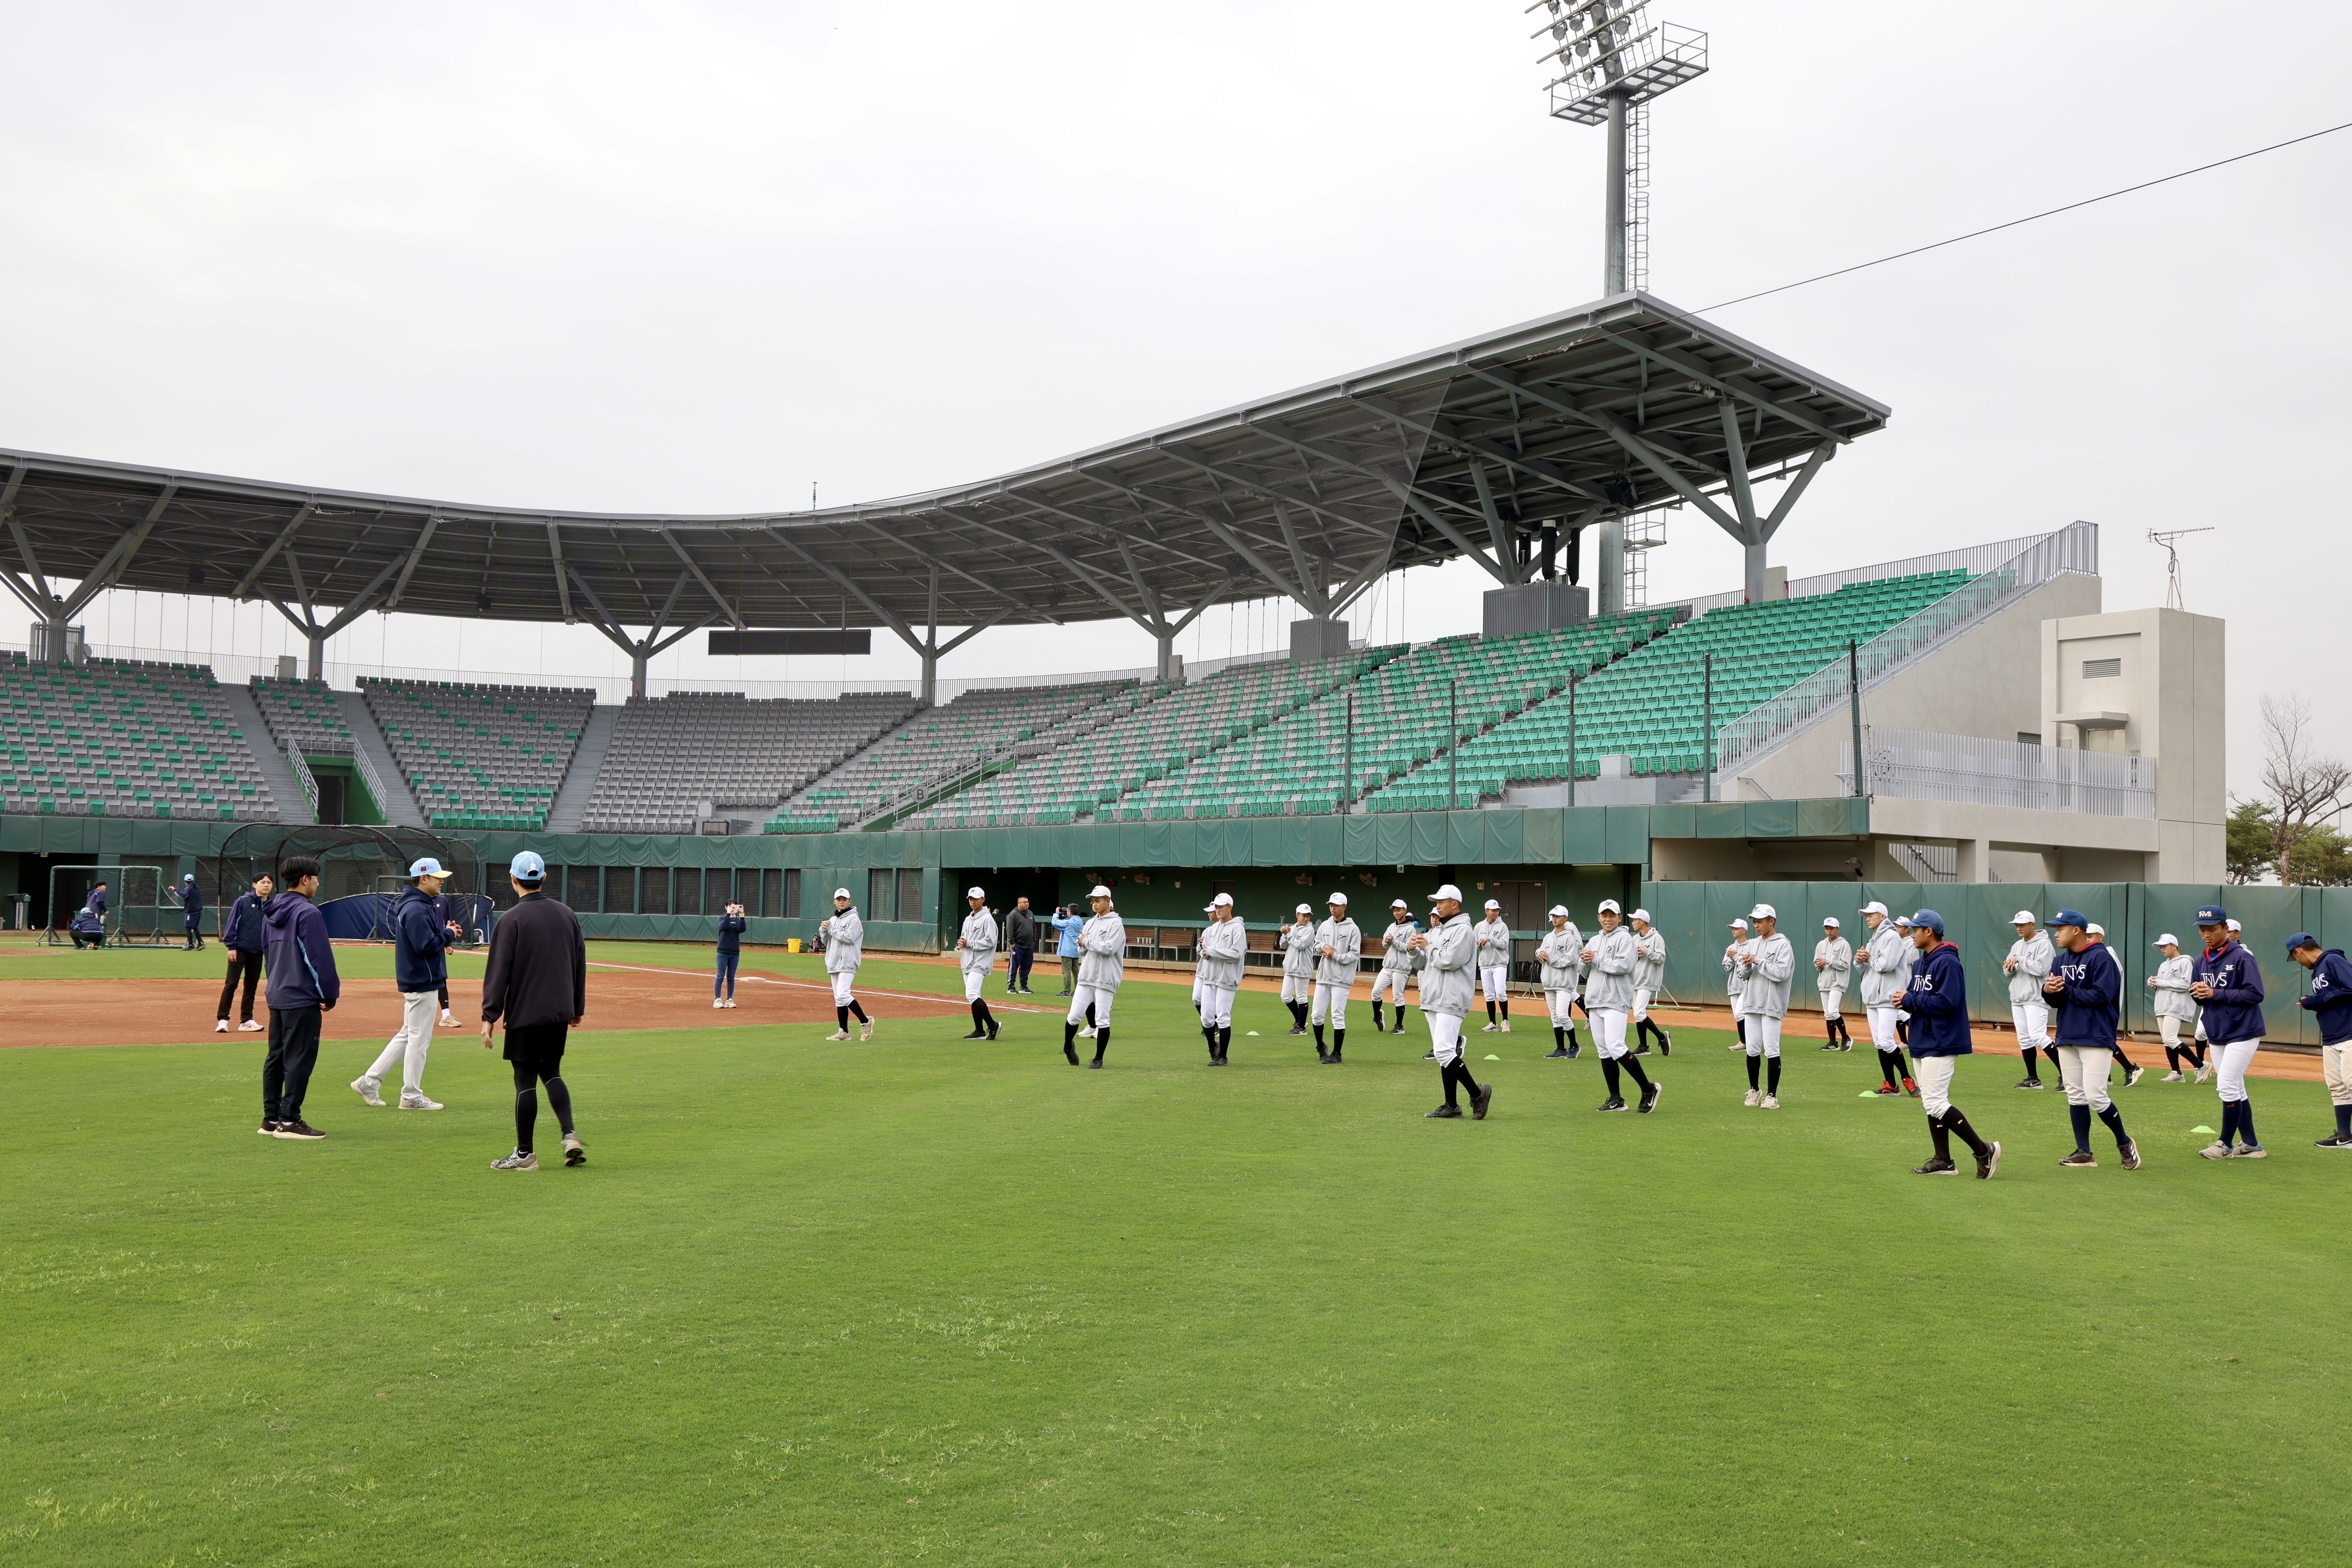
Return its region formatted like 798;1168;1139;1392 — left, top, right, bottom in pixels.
0;799;2352;1044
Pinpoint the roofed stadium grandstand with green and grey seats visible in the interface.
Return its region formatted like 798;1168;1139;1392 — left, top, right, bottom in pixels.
0;294;2225;952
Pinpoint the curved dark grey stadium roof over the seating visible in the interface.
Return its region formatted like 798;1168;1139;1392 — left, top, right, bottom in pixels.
0;294;1888;653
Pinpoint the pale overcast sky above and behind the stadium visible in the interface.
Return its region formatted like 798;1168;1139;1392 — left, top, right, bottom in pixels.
0;0;2352;790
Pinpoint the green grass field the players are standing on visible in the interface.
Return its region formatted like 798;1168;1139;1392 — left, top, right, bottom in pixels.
0;950;2352;1568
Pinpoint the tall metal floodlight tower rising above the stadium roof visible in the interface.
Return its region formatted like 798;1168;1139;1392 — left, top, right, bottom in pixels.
1526;0;1708;299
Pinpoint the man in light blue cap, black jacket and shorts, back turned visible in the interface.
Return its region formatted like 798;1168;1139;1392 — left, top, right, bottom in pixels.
482;849;588;1171
